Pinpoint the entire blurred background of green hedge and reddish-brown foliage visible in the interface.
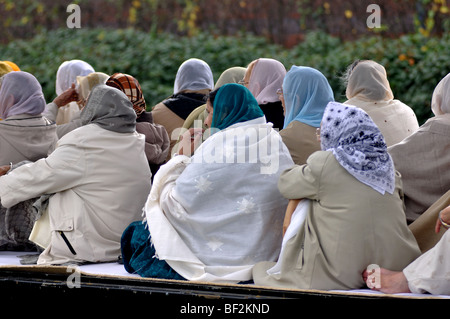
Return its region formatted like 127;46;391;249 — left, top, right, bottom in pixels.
0;0;450;124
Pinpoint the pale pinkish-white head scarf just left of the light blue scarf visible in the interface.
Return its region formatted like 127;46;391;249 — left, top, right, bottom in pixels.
248;58;286;105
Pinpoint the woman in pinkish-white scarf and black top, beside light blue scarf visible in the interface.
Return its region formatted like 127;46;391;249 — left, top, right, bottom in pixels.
242;58;286;130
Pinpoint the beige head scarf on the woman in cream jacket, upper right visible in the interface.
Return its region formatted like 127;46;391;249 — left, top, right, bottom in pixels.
346;60;394;101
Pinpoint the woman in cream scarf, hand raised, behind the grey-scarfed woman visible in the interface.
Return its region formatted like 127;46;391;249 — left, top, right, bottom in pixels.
54;72;109;138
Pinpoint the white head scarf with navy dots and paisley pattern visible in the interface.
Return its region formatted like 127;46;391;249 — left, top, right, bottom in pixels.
320;102;395;194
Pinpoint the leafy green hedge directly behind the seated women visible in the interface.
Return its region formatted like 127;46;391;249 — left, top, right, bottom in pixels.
0;29;450;123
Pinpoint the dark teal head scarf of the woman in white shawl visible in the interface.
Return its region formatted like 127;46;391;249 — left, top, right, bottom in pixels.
211;83;264;130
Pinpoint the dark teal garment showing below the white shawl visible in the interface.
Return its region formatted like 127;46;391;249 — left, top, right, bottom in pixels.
121;222;185;280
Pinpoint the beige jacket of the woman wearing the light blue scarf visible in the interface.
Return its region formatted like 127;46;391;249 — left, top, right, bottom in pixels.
280;121;320;165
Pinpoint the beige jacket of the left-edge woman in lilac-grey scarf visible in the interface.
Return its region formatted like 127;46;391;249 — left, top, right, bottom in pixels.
0;114;58;166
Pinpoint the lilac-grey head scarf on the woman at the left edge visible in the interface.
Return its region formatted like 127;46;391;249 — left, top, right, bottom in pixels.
0;71;46;119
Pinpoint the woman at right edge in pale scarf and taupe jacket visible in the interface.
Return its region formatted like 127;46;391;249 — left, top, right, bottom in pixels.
388;73;450;223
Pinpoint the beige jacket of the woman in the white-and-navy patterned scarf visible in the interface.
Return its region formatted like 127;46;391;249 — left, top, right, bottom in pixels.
253;151;420;290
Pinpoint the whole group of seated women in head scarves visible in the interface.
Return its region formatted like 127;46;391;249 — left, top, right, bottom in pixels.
0;58;450;291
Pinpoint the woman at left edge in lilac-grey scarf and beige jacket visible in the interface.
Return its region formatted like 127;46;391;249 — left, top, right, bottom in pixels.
0;71;58;165
